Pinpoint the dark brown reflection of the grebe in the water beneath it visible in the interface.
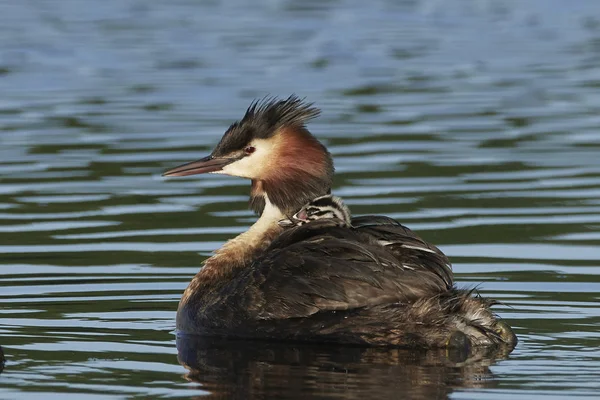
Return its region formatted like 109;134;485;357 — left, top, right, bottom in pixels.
177;335;511;400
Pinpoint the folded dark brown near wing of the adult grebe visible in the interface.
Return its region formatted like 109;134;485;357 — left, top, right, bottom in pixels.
240;220;451;319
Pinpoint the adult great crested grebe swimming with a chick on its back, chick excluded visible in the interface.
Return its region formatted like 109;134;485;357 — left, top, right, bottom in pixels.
164;96;517;348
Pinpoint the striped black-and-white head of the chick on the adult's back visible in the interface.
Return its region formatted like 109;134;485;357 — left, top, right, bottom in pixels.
279;195;352;227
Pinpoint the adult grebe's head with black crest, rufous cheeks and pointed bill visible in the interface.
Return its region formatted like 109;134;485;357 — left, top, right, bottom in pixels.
163;95;333;215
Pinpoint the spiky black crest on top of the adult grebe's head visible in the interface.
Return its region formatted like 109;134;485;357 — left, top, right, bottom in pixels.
213;95;321;156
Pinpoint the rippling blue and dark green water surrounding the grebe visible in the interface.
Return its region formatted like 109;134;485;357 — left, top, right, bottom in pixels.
0;0;600;399
